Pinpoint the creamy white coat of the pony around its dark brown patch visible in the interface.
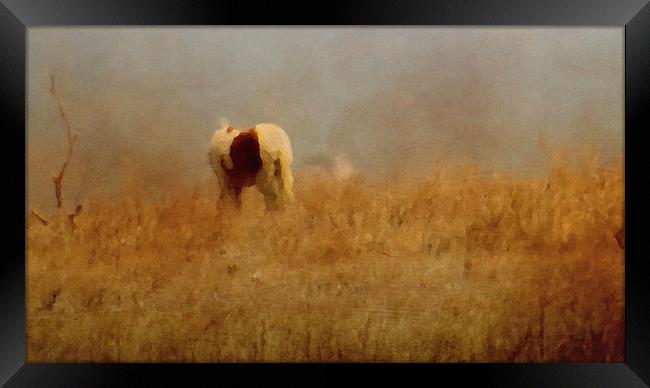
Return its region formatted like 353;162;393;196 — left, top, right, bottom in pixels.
208;120;294;209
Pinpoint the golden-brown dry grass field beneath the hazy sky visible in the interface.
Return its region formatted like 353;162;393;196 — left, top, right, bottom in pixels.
26;147;624;362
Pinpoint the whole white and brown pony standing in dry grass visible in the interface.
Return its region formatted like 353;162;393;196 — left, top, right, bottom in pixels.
208;123;294;209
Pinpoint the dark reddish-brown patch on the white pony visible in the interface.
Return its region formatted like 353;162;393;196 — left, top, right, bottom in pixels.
221;128;262;188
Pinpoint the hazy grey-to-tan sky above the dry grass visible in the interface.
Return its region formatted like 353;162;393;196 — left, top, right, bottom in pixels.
27;27;624;209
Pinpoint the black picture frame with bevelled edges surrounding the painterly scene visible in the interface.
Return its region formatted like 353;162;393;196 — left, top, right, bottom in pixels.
0;0;650;387
